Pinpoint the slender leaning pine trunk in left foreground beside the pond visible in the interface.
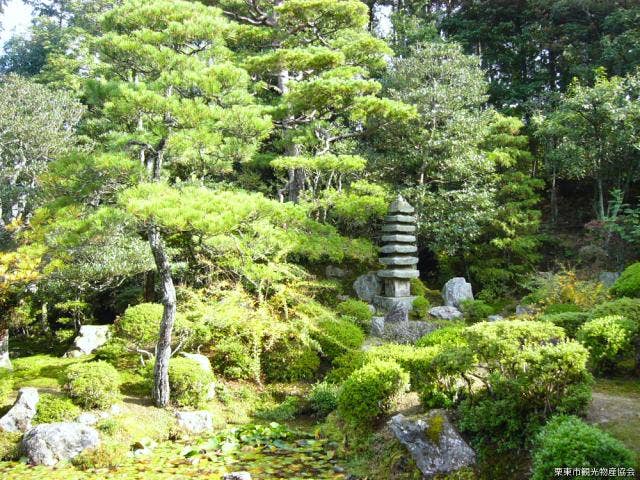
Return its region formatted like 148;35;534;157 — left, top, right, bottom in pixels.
148;225;176;407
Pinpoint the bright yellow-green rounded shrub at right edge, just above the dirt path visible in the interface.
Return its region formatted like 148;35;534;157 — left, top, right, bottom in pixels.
577;315;638;371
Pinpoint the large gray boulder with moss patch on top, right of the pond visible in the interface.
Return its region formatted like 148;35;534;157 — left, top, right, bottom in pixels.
389;410;476;478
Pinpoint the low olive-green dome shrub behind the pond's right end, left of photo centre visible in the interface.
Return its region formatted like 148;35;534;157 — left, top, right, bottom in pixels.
262;339;320;382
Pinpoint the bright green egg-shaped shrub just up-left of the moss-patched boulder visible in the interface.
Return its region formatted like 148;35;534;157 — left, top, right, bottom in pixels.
338;360;409;429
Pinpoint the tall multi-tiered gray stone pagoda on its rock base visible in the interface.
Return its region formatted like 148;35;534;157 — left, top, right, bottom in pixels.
373;195;419;311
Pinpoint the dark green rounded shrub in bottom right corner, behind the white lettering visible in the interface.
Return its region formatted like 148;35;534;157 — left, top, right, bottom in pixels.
531;416;634;480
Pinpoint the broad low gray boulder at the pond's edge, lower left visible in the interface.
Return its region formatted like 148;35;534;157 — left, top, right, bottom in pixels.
21;422;100;466
